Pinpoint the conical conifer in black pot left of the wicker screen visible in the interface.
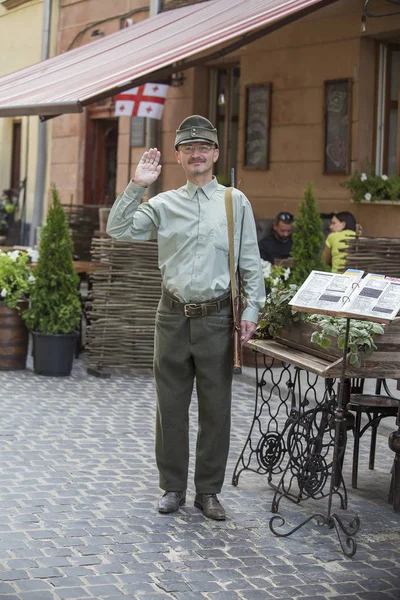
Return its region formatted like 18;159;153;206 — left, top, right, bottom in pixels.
23;185;82;376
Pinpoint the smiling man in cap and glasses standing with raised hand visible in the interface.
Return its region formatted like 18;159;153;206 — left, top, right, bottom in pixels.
107;115;265;520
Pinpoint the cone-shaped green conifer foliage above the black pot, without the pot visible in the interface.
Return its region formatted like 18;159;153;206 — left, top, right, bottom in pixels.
23;186;82;334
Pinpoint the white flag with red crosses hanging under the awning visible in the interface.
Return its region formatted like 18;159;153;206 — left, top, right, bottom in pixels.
115;83;168;119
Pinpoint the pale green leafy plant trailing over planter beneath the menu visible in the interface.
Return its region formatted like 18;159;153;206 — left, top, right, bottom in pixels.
308;315;385;367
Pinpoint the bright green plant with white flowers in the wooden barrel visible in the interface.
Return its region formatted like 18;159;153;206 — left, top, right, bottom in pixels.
0;250;35;308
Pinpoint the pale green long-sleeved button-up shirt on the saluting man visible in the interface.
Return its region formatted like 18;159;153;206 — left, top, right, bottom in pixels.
107;177;265;323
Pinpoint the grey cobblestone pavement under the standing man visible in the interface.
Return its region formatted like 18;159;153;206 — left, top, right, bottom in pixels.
0;360;400;600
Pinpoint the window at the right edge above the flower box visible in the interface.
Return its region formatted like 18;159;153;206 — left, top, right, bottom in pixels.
375;44;400;175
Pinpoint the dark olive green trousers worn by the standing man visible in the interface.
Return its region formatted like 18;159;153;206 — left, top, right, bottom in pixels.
154;294;232;494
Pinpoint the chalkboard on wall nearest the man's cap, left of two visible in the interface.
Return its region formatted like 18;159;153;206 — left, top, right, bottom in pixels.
244;83;272;169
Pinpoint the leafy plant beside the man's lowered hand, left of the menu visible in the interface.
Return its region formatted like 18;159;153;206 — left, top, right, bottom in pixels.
255;279;306;339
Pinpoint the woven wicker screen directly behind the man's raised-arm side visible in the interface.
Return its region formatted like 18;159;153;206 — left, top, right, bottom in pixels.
86;238;161;372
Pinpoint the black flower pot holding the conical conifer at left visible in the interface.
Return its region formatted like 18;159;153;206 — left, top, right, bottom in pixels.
32;331;77;377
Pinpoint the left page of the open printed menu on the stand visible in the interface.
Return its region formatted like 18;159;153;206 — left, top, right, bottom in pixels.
289;269;364;312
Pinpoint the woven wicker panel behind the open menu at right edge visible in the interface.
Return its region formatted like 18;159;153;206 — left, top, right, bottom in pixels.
346;237;400;277
